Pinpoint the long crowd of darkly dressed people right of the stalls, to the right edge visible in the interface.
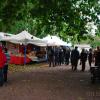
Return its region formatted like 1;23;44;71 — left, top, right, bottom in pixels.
48;47;100;71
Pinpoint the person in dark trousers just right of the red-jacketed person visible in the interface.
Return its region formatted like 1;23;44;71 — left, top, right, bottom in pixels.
3;48;10;82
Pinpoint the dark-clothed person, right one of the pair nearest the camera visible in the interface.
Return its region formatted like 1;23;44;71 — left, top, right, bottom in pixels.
80;49;87;71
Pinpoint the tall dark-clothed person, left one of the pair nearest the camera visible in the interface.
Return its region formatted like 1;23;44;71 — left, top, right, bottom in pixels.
71;46;79;71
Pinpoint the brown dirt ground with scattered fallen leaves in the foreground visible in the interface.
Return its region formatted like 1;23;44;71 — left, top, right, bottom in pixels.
0;64;100;100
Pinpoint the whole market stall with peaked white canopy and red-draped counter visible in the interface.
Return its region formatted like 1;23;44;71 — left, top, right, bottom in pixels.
3;31;46;64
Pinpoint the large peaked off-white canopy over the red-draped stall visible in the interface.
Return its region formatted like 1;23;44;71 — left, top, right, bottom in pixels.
3;31;46;46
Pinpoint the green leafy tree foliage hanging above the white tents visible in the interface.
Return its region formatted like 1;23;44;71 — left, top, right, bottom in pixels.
0;0;100;42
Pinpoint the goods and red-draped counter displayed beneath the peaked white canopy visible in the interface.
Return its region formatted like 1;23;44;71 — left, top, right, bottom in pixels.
7;42;46;64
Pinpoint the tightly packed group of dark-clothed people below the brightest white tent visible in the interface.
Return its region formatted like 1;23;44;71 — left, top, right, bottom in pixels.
47;47;70;67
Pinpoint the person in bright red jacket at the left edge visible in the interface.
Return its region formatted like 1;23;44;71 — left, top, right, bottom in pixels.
0;47;7;86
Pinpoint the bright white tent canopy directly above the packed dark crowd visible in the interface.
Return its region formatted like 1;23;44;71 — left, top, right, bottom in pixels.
43;35;71;46
